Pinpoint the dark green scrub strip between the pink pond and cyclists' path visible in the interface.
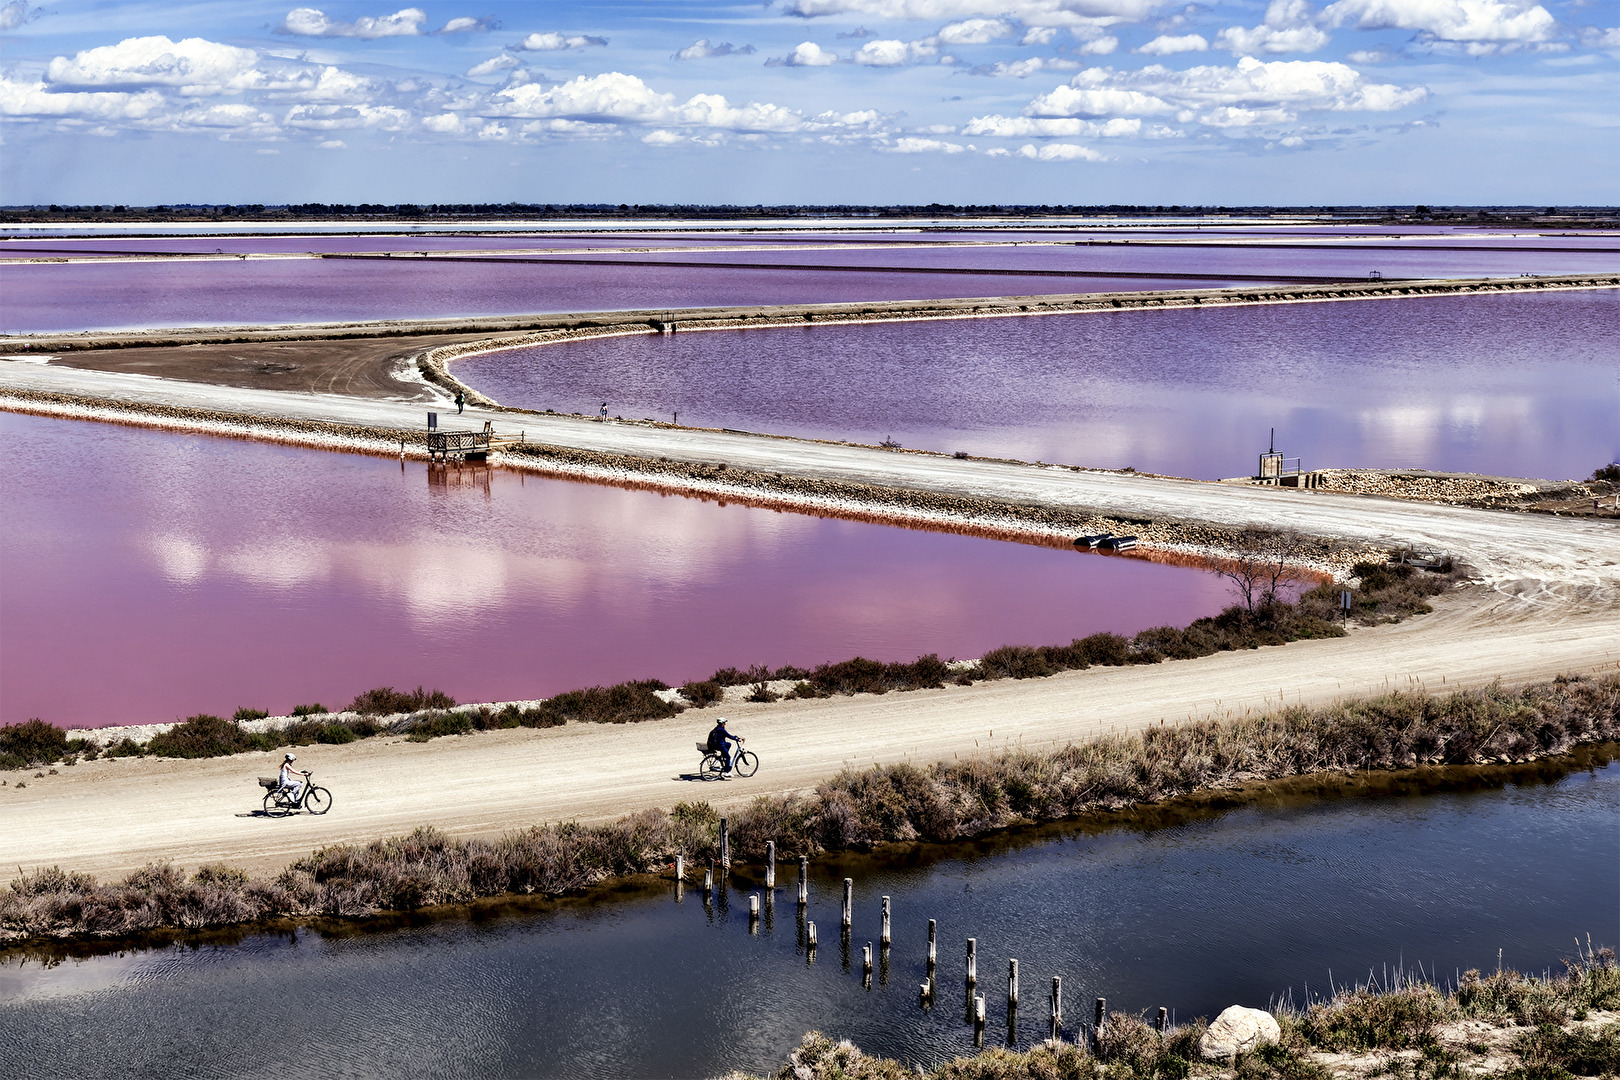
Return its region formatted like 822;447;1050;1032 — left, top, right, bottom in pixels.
0;557;1458;769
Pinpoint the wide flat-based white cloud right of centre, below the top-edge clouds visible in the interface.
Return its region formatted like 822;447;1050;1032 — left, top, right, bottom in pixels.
1024;57;1427;128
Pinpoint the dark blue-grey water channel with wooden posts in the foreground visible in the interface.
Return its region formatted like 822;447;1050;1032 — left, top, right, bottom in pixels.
0;756;1620;1080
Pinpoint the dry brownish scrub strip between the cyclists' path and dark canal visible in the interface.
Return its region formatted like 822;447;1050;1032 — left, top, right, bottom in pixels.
0;675;1620;939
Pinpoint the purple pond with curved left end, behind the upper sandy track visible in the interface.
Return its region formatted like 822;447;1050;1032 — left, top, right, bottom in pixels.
455;290;1620;479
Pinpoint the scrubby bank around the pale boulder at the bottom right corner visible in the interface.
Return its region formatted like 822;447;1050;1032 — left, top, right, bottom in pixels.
738;946;1620;1080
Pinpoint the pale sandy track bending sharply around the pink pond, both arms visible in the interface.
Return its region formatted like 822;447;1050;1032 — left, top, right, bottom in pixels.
0;361;1620;874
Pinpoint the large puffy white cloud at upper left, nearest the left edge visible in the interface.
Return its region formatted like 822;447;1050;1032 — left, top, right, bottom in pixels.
45;36;267;97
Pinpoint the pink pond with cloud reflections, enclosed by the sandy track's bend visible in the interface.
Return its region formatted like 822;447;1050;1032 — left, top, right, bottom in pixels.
0;413;1231;727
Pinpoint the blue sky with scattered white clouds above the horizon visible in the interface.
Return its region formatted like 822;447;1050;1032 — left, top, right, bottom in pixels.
0;0;1620;204
